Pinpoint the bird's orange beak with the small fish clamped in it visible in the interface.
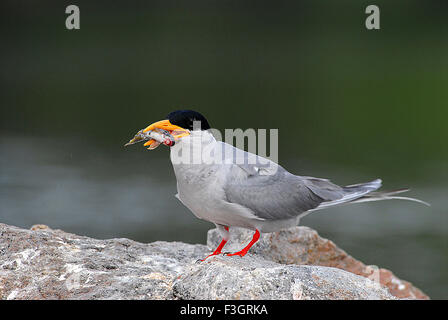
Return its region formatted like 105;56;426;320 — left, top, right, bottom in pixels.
125;120;190;150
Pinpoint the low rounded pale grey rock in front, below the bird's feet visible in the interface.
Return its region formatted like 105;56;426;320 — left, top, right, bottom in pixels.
173;256;394;300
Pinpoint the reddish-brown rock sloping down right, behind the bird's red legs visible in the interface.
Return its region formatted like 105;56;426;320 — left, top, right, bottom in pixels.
207;227;429;299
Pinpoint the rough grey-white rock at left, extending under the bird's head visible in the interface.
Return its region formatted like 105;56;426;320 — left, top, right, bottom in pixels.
0;224;208;299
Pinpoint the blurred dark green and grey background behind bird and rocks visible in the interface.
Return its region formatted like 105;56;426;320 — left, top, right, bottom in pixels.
0;0;448;299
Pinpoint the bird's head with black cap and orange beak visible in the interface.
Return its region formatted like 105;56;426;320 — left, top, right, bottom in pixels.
126;110;210;150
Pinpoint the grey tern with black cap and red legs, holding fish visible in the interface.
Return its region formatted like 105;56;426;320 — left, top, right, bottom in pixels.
126;109;429;261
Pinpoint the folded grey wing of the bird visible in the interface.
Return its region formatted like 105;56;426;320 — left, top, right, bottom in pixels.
221;143;381;220
